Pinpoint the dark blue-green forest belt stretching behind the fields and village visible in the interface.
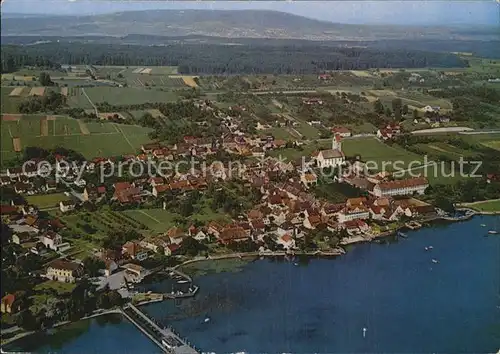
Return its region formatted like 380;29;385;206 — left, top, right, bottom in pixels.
1;43;468;75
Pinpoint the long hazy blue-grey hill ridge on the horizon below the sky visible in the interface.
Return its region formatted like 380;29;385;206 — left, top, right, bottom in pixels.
1;10;498;41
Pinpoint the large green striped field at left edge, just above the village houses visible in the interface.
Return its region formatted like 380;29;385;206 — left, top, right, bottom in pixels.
0;115;150;160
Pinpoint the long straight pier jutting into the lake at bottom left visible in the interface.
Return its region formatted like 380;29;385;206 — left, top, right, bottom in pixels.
122;304;200;354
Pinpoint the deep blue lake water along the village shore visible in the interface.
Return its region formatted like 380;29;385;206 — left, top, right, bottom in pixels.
8;217;500;353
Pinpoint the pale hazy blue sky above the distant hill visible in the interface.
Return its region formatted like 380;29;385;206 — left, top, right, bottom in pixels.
2;0;500;25
